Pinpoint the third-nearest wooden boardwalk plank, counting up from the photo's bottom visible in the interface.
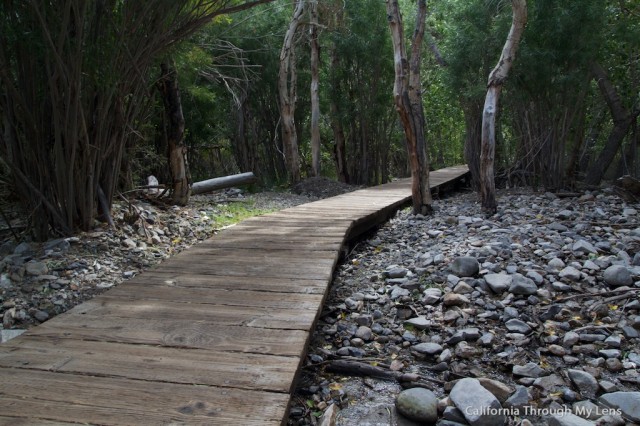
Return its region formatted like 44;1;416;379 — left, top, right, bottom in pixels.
31;315;309;357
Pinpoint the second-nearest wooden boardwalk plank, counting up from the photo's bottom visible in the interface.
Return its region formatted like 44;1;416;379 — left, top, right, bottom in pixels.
0;336;300;393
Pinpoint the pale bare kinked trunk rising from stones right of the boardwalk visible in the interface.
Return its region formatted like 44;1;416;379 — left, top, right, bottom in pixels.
480;0;527;214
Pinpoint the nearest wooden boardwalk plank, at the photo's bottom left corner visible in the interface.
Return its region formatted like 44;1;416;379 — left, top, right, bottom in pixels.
0;368;289;426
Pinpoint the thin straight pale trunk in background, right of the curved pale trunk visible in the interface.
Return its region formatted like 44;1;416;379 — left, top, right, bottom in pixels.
309;0;320;176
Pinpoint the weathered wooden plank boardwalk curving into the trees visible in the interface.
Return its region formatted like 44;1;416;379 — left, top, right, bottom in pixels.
0;166;467;426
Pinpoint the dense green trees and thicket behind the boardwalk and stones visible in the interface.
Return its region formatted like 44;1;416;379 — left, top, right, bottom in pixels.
0;0;640;239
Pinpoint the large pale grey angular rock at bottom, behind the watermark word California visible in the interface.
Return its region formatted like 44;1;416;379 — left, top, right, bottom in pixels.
449;378;507;426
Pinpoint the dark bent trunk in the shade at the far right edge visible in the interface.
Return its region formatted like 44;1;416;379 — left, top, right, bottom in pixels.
585;63;640;185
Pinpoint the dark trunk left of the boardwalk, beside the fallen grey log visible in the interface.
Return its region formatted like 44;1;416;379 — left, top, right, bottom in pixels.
158;62;189;205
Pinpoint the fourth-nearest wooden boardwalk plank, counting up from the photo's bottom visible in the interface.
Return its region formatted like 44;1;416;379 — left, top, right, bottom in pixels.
66;293;318;331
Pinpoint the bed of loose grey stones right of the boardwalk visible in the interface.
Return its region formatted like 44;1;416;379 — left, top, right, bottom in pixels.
289;189;640;426
